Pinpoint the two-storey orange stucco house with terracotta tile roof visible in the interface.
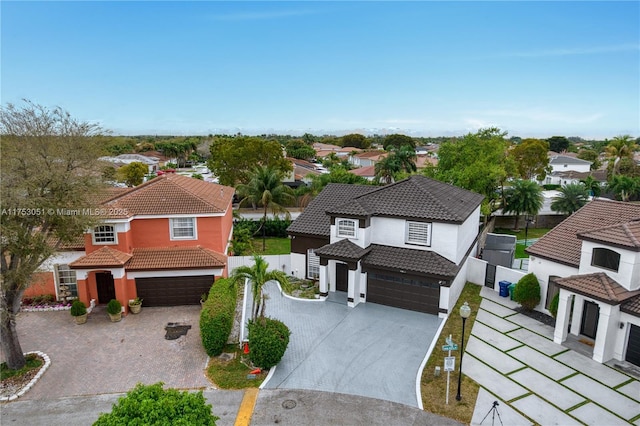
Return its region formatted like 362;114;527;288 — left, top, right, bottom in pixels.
29;173;234;307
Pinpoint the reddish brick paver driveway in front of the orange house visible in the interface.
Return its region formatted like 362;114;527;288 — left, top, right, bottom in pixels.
3;306;213;399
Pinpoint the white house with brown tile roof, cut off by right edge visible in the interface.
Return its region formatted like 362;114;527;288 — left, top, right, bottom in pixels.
527;199;640;366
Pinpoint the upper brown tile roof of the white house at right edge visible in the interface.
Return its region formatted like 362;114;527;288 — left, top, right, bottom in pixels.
526;199;640;268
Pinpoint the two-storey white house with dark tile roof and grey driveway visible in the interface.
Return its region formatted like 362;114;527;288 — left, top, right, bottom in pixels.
288;175;483;317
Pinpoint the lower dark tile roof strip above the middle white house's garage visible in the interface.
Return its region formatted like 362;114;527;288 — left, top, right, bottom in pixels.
362;244;458;279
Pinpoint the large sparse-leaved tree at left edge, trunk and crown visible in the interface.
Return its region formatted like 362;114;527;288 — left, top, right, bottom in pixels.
0;101;103;369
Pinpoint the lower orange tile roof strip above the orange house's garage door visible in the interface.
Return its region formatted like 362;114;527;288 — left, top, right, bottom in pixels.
127;247;227;271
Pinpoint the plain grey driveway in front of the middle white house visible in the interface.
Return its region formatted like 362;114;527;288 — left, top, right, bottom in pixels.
264;283;442;407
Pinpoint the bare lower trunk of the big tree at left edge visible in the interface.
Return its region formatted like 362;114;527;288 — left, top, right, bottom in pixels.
0;291;27;370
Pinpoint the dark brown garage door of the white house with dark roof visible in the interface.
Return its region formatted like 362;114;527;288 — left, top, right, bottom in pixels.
367;271;440;314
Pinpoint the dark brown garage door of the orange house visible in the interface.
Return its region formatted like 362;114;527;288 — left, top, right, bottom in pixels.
136;275;215;306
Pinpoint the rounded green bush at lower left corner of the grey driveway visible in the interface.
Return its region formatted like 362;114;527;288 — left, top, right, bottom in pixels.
249;317;291;368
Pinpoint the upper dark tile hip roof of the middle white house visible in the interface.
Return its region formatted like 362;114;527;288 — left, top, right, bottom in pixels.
327;175;484;224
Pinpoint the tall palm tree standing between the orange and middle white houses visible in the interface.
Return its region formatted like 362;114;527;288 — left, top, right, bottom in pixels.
237;166;295;251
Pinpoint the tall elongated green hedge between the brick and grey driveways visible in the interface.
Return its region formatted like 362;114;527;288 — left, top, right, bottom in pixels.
200;278;237;356
